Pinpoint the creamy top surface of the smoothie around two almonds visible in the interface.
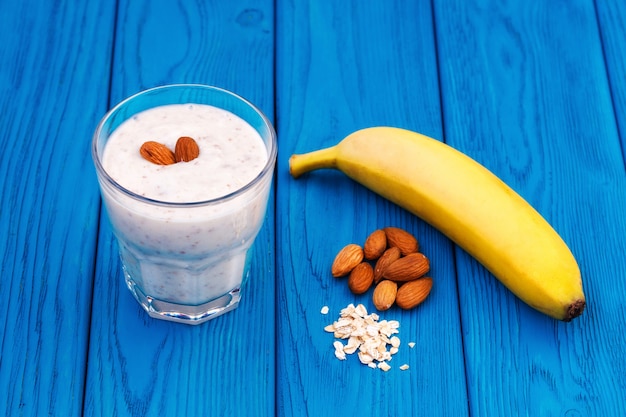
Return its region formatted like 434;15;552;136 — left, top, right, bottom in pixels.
102;104;267;203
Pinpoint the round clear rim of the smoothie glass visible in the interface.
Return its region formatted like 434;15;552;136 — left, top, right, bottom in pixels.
91;83;278;208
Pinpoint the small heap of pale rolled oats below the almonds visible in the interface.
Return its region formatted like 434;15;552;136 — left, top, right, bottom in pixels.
324;304;400;372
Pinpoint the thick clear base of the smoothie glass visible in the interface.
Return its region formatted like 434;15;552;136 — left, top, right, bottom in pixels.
125;274;240;324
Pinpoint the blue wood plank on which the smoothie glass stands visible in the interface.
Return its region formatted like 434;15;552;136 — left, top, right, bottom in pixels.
85;1;275;416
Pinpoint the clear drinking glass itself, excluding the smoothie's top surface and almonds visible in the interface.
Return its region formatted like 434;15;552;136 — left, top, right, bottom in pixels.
92;84;277;324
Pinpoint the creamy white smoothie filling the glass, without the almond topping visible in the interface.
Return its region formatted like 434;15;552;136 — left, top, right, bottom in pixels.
102;104;271;305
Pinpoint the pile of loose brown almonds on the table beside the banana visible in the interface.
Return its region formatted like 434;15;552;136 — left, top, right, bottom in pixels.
331;227;433;311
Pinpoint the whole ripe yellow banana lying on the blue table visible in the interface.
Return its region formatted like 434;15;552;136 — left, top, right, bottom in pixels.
289;127;585;321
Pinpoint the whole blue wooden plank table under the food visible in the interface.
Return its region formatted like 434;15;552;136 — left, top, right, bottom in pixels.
0;0;626;417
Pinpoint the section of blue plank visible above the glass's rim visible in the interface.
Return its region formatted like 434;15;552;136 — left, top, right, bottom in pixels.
111;0;274;117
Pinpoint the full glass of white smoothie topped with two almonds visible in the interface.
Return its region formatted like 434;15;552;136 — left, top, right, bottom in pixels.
92;84;277;324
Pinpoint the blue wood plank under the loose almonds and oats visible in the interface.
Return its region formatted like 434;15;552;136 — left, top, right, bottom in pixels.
277;1;467;416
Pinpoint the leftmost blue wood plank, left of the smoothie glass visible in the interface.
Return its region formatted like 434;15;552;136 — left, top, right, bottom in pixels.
0;0;115;416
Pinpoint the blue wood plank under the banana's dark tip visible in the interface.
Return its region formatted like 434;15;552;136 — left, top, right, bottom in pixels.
435;0;626;416
